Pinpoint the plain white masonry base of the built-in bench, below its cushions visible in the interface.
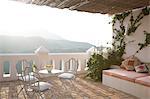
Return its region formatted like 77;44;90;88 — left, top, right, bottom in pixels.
102;74;150;99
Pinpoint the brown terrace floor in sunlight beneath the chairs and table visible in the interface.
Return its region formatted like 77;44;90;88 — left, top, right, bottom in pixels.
0;76;137;99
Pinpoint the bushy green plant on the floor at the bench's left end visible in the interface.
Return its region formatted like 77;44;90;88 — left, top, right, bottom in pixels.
87;53;109;81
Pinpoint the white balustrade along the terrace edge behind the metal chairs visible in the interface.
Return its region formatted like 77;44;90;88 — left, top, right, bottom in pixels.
0;53;89;81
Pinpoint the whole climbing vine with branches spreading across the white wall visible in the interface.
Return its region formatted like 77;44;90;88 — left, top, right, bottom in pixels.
108;7;150;64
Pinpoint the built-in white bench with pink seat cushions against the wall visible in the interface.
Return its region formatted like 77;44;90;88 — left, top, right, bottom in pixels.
103;69;150;99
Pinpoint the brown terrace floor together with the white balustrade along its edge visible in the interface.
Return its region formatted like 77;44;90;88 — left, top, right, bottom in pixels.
0;48;135;99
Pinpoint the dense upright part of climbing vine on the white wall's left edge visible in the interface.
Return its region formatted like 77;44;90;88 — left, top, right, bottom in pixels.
108;12;130;65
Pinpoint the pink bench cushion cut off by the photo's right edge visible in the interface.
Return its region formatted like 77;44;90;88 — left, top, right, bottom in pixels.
135;76;150;87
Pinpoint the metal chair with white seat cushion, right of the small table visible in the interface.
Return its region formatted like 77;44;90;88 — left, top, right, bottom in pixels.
58;58;79;90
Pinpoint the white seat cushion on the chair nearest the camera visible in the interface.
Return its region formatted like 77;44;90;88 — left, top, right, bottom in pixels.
32;82;52;91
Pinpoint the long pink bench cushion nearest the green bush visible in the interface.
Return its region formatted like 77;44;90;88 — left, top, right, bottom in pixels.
103;69;148;82
